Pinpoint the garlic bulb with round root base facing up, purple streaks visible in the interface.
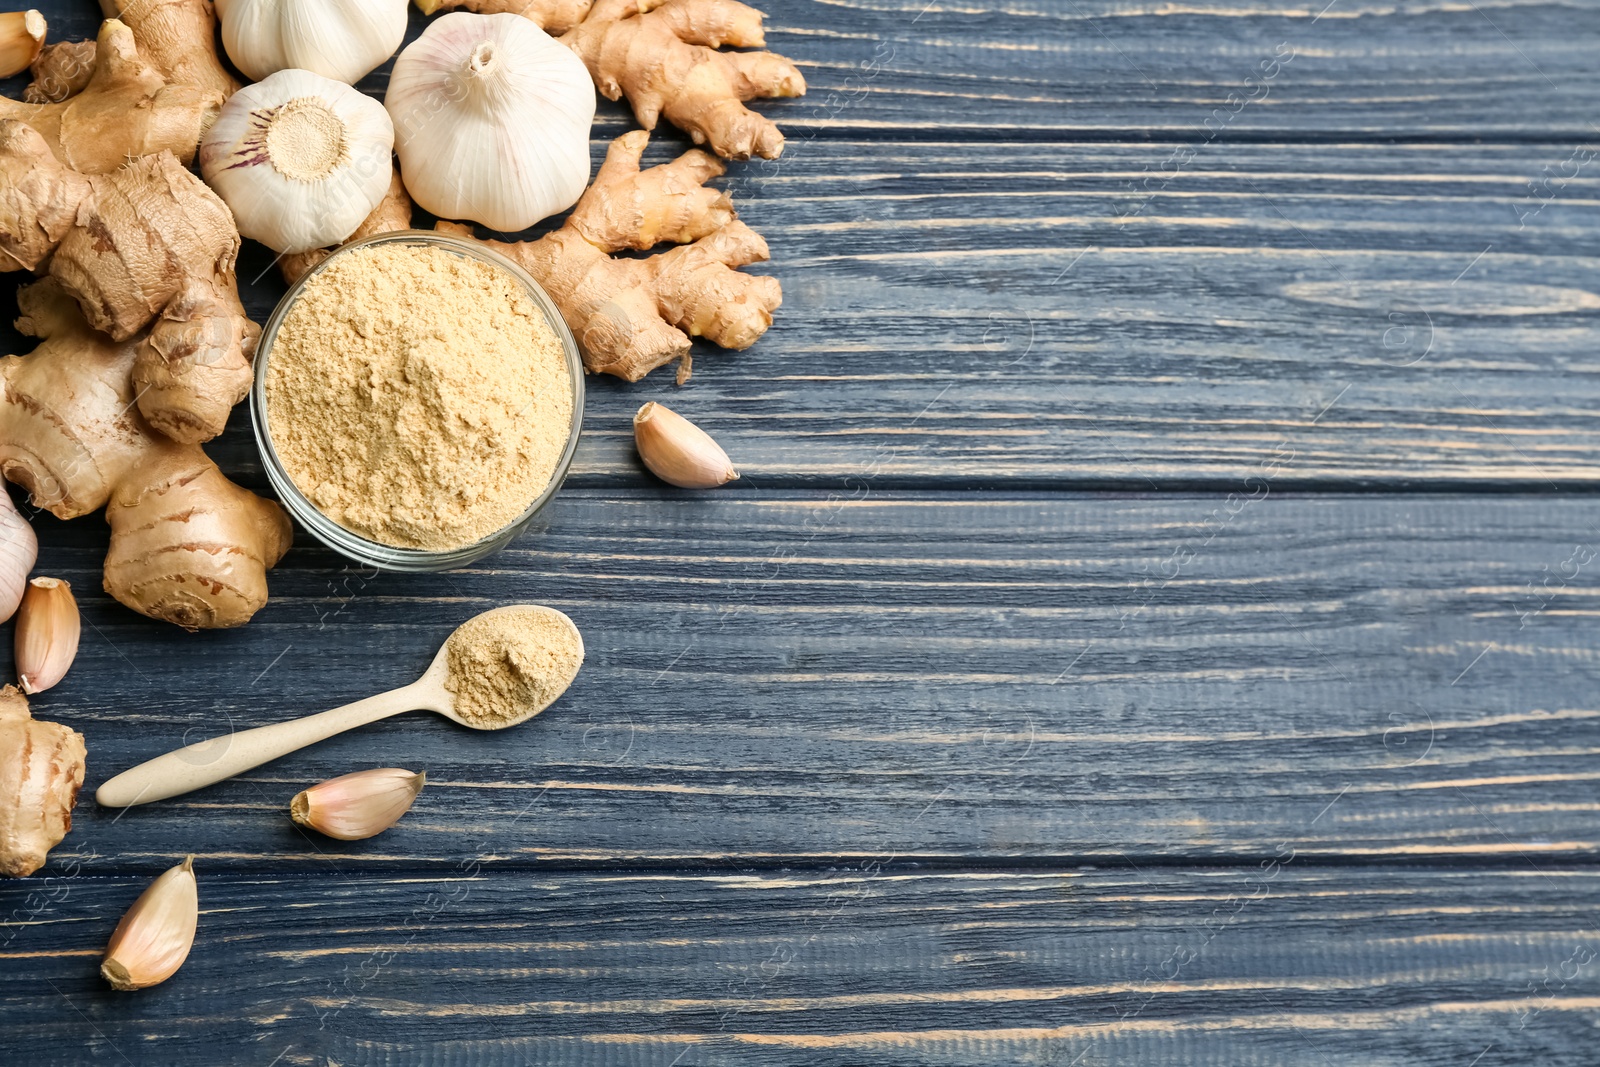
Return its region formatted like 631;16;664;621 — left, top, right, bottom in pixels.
200;70;394;253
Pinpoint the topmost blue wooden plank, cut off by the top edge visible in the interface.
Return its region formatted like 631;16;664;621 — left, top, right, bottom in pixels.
6;0;1600;142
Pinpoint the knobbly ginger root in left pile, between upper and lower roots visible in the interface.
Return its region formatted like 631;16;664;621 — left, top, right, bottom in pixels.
0;119;261;442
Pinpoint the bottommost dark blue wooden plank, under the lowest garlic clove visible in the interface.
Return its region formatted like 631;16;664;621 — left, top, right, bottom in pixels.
0;870;1600;1067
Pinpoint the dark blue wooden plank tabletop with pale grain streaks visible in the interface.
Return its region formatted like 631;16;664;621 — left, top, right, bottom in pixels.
0;0;1600;1067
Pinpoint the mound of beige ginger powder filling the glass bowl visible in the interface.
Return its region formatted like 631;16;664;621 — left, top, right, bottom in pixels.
266;243;573;550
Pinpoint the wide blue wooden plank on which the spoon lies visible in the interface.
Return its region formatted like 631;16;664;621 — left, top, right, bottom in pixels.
12;495;1600;872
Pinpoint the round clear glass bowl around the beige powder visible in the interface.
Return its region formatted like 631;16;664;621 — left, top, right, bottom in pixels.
250;230;584;571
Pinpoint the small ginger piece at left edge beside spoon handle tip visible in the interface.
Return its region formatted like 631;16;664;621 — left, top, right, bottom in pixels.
0;685;85;878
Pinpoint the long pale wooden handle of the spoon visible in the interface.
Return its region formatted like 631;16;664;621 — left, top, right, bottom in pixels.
94;685;426;808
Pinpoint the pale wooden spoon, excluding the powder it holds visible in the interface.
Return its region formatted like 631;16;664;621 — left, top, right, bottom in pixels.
94;605;582;808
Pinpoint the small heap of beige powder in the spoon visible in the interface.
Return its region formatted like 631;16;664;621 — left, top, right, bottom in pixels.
445;605;584;729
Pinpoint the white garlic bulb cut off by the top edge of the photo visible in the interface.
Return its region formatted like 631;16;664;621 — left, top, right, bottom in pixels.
216;0;406;85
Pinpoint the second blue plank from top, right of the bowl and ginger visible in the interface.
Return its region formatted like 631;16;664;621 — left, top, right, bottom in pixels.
5;142;1600;493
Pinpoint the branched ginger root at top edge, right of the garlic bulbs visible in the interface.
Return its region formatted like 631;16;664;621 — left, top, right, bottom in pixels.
416;0;805;160
